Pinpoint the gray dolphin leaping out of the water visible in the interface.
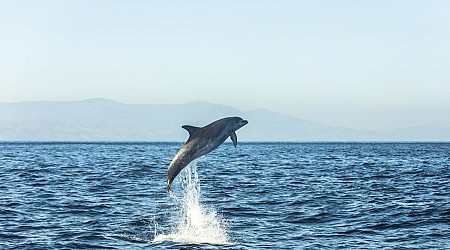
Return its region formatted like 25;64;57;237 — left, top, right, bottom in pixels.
167;117;248;191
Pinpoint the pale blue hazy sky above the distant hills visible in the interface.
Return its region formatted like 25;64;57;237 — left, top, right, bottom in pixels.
0;0;450;130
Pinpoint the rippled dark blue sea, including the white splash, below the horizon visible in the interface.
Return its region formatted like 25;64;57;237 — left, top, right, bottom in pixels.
0;143;450;249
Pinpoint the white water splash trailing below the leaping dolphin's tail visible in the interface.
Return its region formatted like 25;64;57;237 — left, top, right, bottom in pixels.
153;161;231;245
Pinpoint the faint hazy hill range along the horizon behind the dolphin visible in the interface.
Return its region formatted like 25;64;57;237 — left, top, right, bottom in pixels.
0;99;450;142
